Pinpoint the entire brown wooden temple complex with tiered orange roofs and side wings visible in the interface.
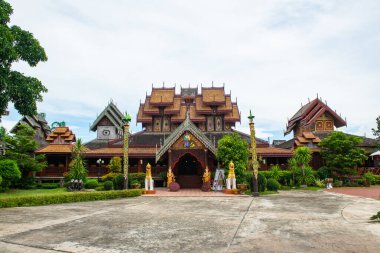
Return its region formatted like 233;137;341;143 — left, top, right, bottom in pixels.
23;87;378;188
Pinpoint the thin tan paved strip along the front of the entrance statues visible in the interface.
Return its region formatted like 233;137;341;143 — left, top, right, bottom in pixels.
143;188;249;197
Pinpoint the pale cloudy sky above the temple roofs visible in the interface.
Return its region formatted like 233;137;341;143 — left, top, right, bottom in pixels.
1;0;380;140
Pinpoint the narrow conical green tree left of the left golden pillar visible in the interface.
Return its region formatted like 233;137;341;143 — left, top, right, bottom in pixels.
69;139;87;182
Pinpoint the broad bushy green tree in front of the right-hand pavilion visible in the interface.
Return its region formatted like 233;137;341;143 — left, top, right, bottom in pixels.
319;132;367;177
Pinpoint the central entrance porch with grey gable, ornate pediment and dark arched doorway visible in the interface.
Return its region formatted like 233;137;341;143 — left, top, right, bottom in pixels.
156;112;216;188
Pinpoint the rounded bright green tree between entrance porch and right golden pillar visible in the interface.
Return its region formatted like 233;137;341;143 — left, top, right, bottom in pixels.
216;133;249;183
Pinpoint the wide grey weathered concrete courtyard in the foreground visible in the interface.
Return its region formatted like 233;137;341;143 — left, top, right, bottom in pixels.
0;191;380;253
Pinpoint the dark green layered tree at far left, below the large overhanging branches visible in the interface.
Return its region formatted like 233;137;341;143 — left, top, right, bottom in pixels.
0;124;47;188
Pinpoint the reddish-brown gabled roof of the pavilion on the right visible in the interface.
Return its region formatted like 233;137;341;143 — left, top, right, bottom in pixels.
284;98;347;135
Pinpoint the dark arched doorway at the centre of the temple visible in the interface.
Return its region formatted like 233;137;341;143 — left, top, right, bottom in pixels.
173;154;203;188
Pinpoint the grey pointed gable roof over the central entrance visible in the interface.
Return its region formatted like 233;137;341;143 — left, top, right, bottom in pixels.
156;112;216;161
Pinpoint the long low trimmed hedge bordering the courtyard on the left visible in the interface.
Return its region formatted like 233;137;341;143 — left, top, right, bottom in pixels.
0;189;142;208
